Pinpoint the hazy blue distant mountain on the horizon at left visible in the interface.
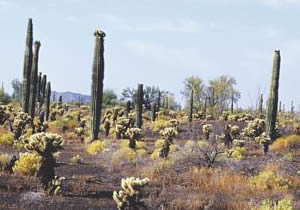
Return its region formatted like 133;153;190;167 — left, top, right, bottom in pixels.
51;91;91;104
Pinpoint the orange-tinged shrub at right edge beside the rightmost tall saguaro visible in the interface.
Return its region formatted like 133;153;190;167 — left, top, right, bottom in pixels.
271;135;300;152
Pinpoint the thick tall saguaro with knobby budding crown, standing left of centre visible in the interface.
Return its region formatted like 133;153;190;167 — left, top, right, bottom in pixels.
90;30;105;141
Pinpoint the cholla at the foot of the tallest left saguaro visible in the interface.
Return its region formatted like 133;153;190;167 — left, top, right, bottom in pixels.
12;112;31;140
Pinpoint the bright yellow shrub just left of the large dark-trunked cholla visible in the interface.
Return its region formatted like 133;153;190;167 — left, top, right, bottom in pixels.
13;152;42;176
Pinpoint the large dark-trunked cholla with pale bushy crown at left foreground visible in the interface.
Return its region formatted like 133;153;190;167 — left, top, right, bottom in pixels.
22;133;64;190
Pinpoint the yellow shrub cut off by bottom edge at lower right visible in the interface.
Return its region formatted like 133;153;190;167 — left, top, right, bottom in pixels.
258;198;293;210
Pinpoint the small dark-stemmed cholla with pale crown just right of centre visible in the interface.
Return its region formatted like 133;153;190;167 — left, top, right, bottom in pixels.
159;128;178;158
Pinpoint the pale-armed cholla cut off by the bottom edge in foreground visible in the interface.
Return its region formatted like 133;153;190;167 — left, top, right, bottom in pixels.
113;177;150;210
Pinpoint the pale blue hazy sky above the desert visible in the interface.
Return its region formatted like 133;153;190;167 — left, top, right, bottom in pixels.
0;0;300;108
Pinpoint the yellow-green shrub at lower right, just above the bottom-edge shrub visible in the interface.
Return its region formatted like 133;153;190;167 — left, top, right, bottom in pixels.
249;168;291;190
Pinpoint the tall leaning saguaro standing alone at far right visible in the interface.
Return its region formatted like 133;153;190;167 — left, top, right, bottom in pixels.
266;50;281;142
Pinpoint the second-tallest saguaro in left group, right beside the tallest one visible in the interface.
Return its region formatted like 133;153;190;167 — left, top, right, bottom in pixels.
29;41;41;120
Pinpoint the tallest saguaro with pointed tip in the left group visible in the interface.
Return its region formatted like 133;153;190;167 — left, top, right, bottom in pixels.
22;18;33;113
